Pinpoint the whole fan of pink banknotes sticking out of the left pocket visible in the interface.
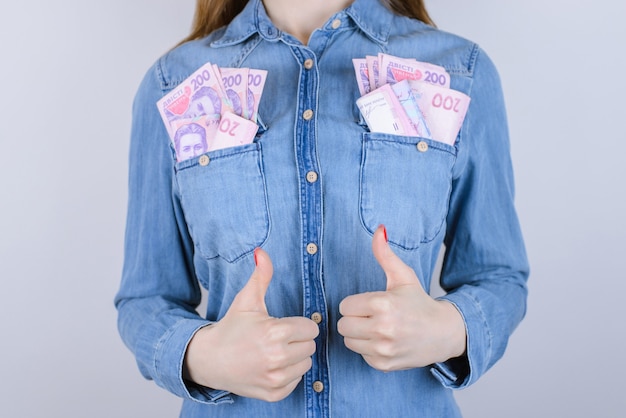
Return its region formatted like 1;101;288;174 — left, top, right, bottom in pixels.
157;62;267;161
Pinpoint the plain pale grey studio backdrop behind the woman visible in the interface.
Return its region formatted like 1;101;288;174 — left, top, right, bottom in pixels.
0;0;626;418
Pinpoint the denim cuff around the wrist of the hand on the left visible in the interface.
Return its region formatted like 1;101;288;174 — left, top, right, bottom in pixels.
154;319;233;404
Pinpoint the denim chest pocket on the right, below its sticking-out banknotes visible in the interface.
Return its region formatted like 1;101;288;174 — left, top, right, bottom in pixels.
360;132;456;250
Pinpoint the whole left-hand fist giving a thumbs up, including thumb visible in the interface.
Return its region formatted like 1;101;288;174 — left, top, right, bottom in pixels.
180;249;319;402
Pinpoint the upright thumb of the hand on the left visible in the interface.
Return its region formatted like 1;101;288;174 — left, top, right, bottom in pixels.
230;248;274;313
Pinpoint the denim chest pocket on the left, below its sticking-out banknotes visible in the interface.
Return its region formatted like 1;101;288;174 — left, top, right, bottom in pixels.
176;142;269;262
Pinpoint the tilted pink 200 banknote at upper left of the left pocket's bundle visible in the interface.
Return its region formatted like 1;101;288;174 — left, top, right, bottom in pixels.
157;63;233;138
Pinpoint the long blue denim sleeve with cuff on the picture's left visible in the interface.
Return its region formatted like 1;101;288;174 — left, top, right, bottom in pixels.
115;59;230;403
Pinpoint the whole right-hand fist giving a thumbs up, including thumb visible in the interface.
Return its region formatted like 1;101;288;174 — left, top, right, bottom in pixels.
337;226;466;371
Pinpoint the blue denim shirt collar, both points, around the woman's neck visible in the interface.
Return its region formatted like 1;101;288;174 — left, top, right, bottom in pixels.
211;0;393;47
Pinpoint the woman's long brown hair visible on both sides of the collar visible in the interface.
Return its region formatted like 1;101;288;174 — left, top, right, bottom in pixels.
181;0;435;44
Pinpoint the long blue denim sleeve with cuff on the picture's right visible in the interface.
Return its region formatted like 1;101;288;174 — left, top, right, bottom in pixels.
431;47;529;388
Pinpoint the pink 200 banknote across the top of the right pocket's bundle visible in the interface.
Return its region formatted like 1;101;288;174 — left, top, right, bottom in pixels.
378;54;450;88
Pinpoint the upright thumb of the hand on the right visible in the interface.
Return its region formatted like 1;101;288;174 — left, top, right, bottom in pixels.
372;225;419;290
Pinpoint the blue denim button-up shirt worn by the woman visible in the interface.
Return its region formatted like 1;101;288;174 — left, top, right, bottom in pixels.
116;0;528;417
